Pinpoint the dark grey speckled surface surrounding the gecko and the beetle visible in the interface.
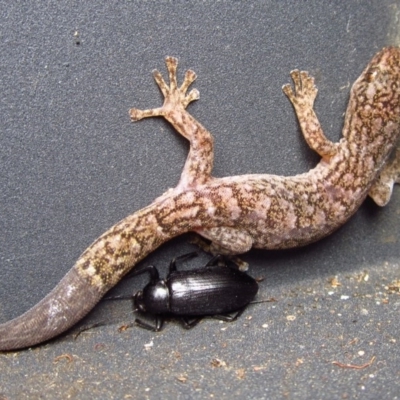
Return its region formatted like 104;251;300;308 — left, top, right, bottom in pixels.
0;0;400;399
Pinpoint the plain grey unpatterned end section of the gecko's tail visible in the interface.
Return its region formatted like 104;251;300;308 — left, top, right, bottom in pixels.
0;267;104;351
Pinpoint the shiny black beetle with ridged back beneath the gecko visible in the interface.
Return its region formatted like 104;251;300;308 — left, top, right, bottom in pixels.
130;252;258;332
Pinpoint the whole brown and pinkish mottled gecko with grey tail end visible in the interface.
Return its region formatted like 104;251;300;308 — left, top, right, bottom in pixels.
0;48;400;351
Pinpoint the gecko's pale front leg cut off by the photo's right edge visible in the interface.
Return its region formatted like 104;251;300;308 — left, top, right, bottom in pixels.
368;148;400;207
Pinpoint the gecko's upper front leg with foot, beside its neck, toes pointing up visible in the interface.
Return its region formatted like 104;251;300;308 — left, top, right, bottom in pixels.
282;69;337;160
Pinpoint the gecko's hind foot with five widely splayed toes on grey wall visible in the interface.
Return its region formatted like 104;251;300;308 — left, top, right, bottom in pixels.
129;57;200;121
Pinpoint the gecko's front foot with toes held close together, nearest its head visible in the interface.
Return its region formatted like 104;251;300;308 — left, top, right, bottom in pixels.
282;69;318;108
